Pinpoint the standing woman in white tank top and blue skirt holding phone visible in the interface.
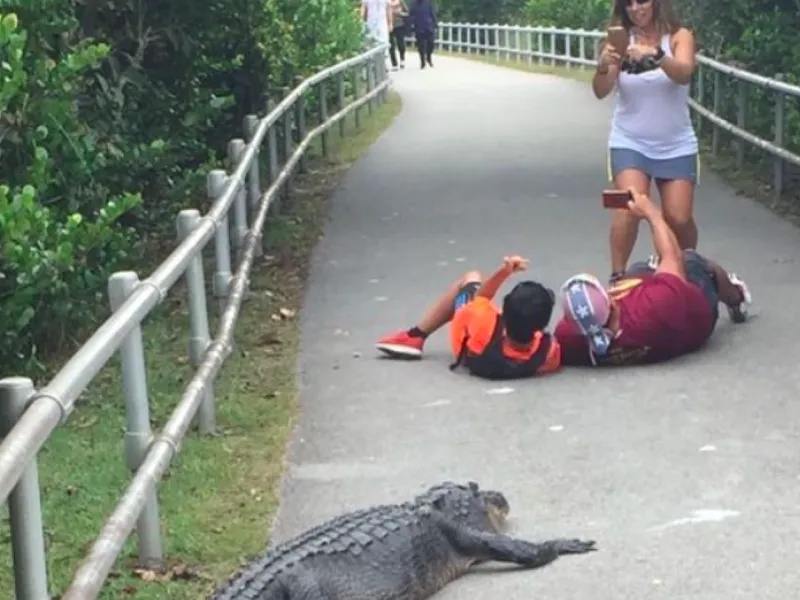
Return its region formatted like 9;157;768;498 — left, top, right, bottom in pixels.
592;0;699;280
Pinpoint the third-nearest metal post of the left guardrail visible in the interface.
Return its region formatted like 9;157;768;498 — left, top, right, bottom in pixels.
176;209;216;435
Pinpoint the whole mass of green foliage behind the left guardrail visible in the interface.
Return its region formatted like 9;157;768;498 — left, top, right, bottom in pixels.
0;0;362;375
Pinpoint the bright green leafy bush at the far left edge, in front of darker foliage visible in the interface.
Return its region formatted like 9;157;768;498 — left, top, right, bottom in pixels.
0;13;139;364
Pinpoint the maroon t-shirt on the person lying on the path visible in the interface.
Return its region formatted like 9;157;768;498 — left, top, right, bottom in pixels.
554;273;714;365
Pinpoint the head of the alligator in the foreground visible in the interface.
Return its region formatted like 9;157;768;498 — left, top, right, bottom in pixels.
416;481;510;533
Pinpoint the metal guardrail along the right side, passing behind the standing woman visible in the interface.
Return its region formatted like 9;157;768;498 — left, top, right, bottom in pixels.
422;23;800;197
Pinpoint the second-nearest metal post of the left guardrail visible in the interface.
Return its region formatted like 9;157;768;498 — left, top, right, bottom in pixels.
108;271;164;569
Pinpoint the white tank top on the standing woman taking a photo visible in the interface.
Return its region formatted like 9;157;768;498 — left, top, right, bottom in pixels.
608;34;697;160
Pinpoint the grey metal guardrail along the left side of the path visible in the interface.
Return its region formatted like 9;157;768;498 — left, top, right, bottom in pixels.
0;45;390;600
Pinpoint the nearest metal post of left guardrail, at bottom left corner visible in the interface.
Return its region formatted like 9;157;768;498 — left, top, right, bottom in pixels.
0;377;50;600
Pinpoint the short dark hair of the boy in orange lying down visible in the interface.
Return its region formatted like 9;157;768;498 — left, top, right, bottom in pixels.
503;281;555;344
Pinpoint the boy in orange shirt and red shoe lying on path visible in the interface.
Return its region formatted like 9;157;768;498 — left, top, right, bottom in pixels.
376;256;561;379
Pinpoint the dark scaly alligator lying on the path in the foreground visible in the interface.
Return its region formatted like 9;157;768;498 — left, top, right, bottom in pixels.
209;481;596;600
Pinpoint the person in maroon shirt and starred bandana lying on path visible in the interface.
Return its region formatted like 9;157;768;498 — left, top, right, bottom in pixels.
554;191;751;366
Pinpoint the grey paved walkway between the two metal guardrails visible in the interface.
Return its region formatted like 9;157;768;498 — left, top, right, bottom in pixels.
276;56;800;600
